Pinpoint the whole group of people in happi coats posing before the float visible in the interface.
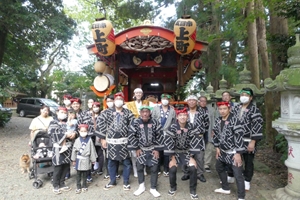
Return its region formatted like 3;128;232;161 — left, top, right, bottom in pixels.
29;88;263;199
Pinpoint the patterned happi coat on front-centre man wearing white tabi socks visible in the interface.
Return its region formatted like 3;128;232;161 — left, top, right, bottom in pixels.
127;118;164;166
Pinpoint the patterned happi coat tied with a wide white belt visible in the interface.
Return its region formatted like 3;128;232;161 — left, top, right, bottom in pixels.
95;108;134;161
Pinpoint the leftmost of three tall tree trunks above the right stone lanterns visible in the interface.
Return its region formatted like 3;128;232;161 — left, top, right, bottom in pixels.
246;1;260;88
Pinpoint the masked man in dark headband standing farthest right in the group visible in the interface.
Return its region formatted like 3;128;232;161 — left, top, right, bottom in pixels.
233;88;263;190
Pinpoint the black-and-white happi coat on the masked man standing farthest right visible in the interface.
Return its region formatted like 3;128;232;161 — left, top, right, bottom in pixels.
233;102;264;152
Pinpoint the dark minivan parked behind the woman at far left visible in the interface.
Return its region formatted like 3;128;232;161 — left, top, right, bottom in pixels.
16;97;59;117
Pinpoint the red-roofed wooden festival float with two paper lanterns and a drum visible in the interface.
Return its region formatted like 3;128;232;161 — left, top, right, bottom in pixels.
87;15;208;101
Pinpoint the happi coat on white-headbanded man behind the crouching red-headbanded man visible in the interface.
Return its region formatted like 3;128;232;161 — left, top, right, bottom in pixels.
188;107;209;151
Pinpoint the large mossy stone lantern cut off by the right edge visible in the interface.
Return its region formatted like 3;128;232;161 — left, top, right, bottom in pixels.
265;34;300;200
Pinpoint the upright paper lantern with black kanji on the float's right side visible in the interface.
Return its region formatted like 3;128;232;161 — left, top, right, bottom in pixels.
174;15;197;55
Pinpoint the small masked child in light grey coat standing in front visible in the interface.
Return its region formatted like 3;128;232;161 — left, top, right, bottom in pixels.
71;124;97;194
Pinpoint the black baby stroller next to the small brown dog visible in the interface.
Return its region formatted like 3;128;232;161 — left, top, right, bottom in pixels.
29;131;54;189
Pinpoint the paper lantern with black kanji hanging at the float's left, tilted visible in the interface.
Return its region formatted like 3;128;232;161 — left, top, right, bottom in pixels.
92;18;116;56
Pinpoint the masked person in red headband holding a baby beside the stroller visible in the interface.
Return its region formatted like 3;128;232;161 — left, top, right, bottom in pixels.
48;107;76;194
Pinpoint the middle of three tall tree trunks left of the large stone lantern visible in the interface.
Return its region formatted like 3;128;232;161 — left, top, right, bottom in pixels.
255;0;275;146
